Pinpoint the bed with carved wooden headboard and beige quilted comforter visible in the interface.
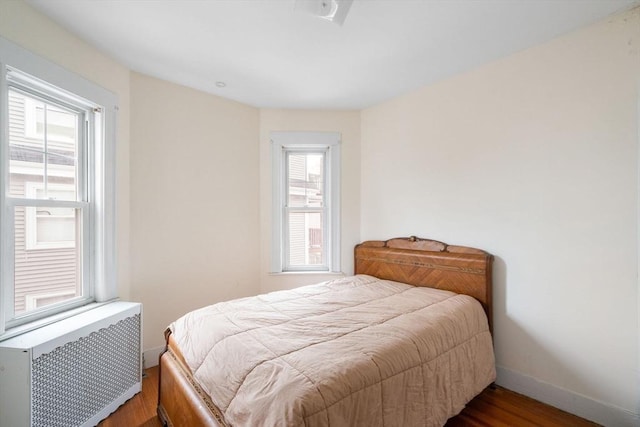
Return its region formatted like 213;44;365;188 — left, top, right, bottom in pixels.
158;237;495;427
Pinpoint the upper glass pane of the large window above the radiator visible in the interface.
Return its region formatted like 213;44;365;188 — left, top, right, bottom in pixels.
9;90;81;200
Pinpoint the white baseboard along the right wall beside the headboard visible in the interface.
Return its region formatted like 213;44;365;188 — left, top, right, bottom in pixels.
496;366;640;427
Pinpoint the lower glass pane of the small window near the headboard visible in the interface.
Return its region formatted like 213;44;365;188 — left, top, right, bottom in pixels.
288;212;325;266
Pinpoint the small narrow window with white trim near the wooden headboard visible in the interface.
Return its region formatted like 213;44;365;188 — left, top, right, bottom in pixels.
271;132;340;272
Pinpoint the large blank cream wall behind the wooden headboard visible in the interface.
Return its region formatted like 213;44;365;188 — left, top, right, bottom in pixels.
361;9;640;425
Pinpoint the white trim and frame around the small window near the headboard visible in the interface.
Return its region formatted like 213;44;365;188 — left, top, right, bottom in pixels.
270;132;341;273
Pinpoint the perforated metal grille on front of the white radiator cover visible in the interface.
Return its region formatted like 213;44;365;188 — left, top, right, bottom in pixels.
32;314;141;427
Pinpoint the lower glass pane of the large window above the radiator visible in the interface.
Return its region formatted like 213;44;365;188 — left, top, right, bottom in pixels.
14;206;82;315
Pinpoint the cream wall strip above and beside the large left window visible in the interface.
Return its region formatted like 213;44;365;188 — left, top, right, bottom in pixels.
0;0;130;299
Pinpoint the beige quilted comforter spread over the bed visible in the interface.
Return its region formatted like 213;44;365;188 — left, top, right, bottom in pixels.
171;276;495;427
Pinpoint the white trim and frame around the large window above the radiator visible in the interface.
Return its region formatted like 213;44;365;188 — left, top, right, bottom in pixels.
0;37;118;340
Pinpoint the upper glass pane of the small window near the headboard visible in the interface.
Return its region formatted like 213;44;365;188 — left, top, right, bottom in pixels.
287;153;324;207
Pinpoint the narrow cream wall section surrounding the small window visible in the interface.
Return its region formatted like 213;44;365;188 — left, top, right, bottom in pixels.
260;109;360;292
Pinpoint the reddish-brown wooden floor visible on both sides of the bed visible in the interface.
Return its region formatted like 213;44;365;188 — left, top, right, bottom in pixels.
98;366;597;427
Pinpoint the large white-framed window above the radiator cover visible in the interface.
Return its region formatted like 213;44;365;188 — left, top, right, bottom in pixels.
0;38;116;339
